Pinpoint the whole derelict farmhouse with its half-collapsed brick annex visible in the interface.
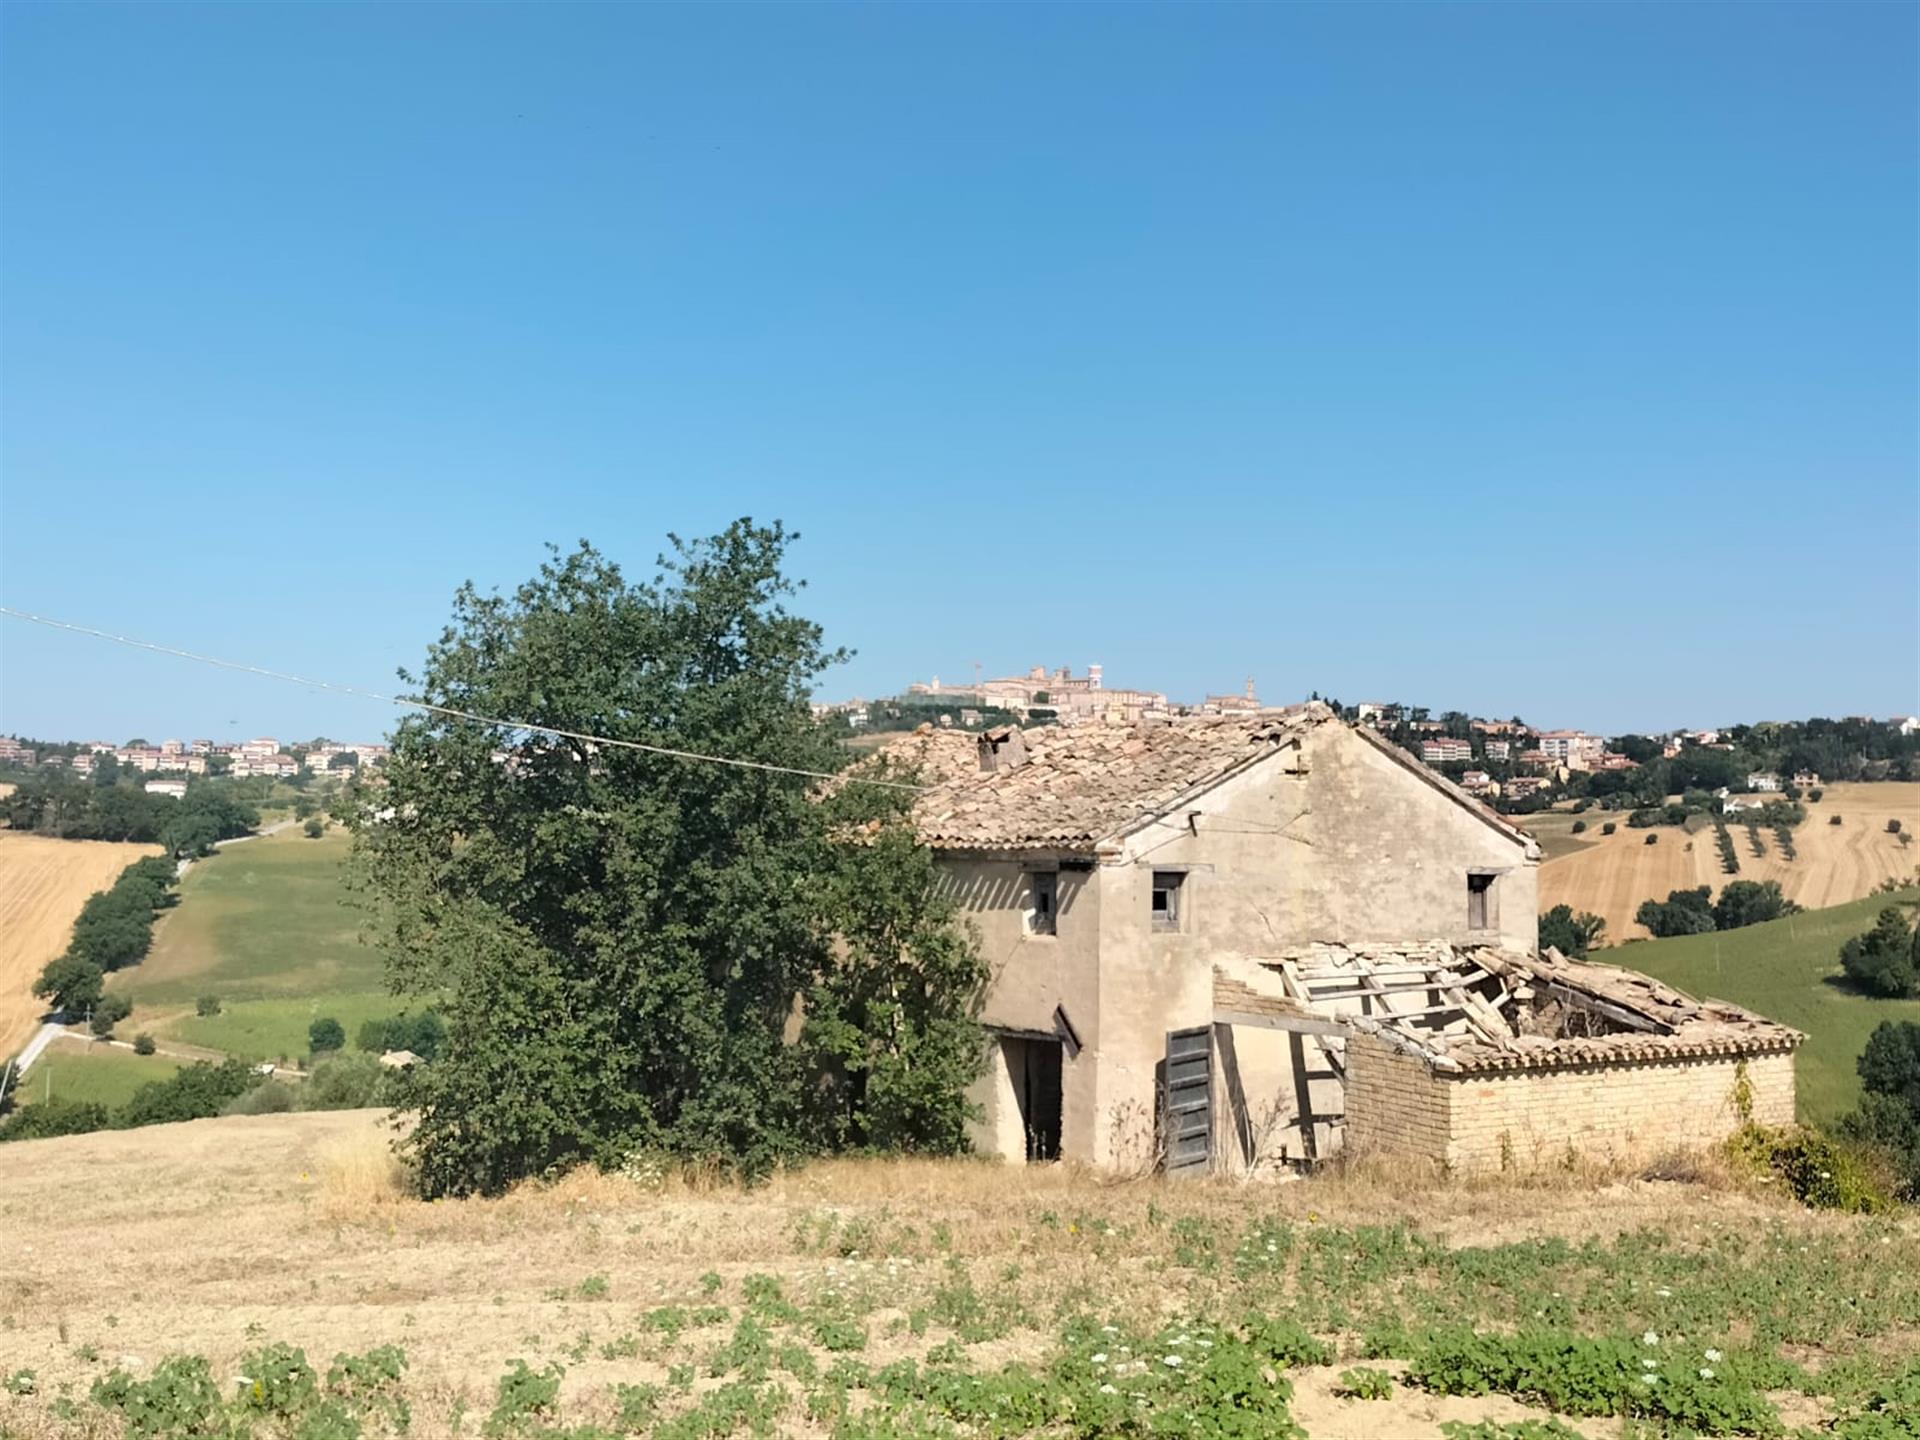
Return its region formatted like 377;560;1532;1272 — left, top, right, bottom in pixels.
883;705;1801;1171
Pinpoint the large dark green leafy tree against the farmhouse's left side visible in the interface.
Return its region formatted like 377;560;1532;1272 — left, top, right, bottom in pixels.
351;520;981;1194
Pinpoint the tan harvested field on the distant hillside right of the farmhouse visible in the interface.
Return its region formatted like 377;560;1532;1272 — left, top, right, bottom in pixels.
1523;781;1920;945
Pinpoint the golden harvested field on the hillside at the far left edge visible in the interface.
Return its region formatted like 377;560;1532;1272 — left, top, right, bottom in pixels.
0;829;161;1056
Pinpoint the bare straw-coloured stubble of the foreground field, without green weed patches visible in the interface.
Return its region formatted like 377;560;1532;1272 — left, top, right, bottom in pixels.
0;1112;1920;1440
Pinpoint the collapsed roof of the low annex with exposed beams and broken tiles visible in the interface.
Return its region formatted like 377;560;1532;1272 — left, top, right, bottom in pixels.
1213;941;1805;1073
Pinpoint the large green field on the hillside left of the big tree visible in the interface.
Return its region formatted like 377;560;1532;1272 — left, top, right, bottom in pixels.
113;826;405;1060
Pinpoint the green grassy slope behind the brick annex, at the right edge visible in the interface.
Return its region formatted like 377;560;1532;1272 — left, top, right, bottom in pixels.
1620;891;1920;1123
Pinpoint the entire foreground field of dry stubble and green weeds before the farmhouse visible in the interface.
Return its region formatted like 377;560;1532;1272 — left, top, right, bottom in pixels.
0;1112;1920;1440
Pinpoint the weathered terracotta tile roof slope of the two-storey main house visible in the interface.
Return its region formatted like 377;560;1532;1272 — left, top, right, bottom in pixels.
914;705;1332;852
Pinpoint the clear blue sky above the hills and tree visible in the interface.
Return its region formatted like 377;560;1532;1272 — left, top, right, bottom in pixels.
0;4;1920;739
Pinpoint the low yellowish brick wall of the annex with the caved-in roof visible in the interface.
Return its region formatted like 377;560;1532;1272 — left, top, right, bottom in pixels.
1346;1037;1793;1173
